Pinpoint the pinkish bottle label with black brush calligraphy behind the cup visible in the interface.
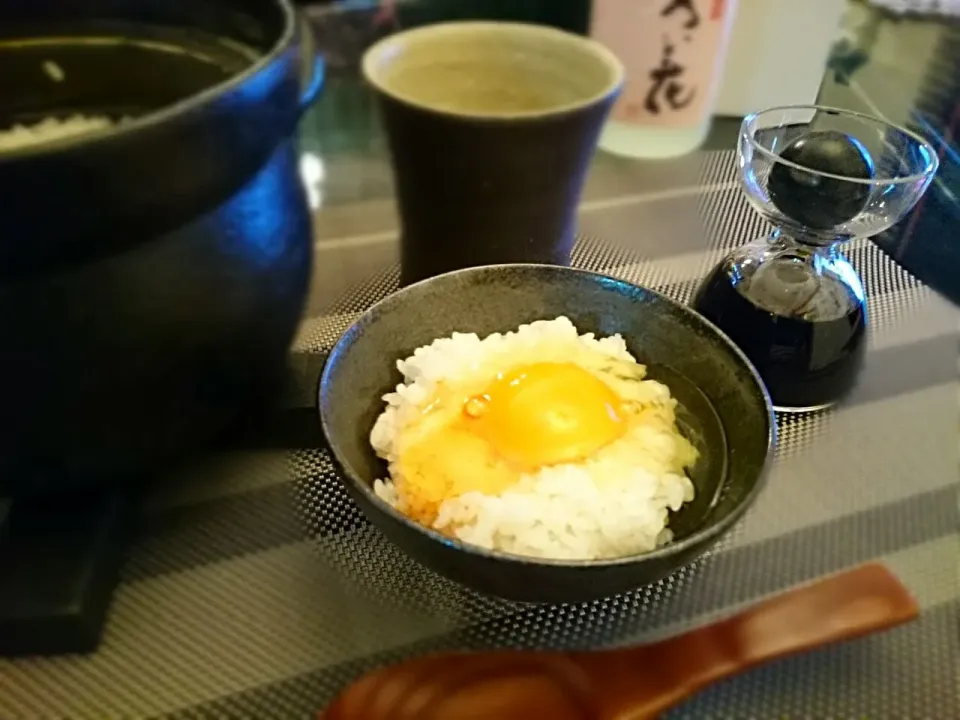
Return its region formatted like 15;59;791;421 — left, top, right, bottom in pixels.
590;0;735;127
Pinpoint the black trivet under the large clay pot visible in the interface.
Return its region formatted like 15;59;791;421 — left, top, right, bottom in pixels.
0;353;326;656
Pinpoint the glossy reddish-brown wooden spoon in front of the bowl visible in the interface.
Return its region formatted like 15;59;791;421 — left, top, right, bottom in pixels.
318;564;917;720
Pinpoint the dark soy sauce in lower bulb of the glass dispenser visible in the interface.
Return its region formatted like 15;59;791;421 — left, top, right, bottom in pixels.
693;262;867;411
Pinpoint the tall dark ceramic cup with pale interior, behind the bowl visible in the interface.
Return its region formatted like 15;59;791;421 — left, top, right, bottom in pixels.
363;22;624;285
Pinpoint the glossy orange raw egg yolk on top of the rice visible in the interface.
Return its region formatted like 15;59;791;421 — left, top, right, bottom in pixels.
463;362;626;468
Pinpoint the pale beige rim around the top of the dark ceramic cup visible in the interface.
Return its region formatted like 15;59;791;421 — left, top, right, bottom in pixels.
361;20;626;122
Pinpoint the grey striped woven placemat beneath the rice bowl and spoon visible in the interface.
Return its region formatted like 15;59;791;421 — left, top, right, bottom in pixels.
0;2;960;720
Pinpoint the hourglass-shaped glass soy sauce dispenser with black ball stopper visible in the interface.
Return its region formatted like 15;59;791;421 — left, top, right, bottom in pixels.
693;106;938;412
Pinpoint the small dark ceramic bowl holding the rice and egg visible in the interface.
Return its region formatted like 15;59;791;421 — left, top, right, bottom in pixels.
320;265;776;602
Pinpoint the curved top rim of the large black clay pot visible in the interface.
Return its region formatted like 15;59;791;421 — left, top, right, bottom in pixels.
0;0;298;166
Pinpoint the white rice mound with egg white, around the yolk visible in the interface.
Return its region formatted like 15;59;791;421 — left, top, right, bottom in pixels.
370;317;697;560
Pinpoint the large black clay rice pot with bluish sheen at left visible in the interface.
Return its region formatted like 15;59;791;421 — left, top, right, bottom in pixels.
0;0;322;493
